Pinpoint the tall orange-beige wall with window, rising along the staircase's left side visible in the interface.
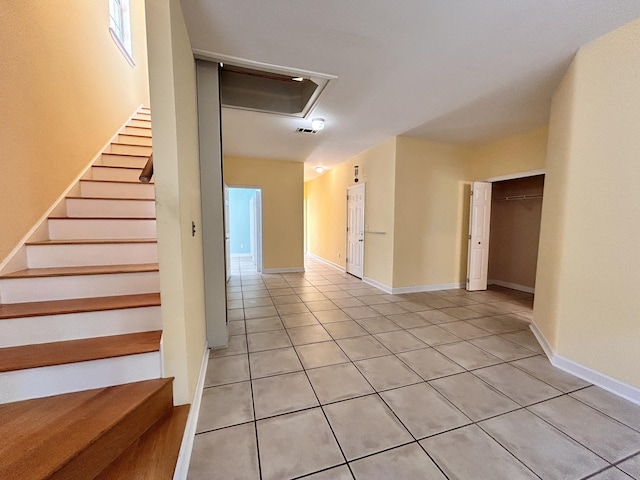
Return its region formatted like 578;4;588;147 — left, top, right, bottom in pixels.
0;0;149;263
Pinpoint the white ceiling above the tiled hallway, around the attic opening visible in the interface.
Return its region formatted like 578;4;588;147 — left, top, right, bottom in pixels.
182;0;640;179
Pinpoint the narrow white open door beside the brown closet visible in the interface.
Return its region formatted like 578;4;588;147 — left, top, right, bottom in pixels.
467;182;491;291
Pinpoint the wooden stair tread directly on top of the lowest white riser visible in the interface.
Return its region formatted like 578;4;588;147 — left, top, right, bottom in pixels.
0;330;162;374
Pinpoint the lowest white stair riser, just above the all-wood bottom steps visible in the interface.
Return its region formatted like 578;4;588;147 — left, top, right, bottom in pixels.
0;352;162;403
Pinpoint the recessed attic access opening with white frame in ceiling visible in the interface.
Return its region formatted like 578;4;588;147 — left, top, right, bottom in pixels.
220;64;326;117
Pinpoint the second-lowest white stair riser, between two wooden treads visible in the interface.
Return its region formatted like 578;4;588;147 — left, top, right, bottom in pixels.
0;306;162;348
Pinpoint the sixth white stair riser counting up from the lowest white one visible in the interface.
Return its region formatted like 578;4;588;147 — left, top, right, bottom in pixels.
66;198;156;218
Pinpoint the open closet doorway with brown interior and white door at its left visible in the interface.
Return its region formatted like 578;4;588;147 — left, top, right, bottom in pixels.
467;171;544;293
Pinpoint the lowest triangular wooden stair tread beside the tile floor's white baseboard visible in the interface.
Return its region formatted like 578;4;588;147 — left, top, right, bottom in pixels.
96;405;190;480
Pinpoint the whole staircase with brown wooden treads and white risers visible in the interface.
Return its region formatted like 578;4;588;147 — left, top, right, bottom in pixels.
0;108;189;480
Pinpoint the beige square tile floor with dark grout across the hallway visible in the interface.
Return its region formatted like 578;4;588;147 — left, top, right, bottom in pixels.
189;260;640;480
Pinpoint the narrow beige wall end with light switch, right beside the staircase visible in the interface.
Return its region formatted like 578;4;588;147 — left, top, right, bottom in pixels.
147;0;206;404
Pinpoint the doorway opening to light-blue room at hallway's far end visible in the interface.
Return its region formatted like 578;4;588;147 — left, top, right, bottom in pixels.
228;187;262;272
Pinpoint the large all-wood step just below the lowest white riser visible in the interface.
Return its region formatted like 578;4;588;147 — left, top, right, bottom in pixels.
0;379;172;480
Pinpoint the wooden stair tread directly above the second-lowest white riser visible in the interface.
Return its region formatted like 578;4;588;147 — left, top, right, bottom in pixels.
0;293;160;320
